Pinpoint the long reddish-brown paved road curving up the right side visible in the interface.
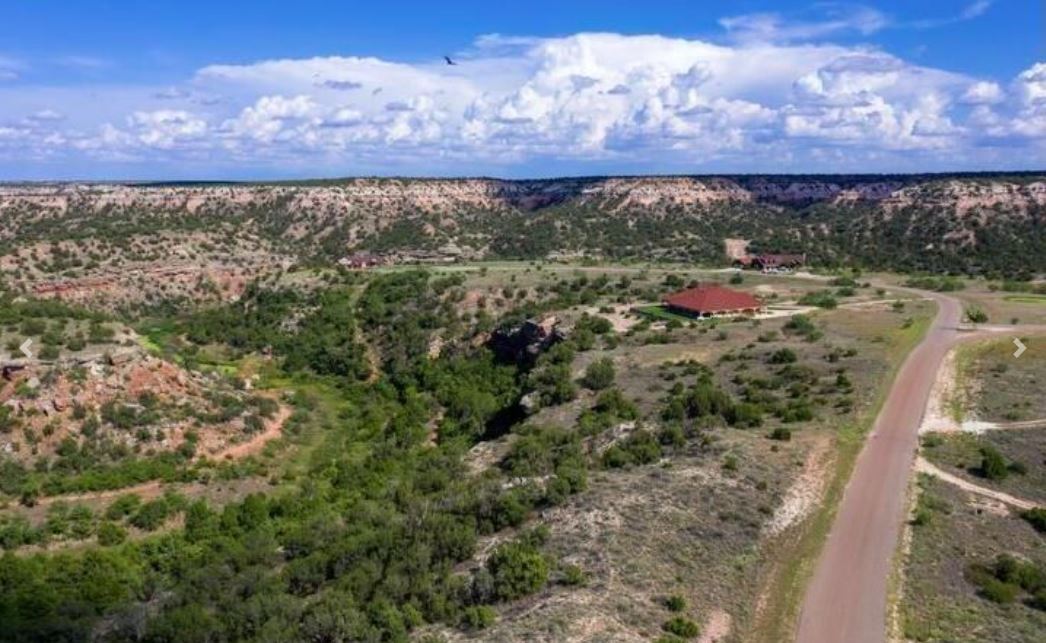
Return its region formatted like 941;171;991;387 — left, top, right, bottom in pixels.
797;294;963;643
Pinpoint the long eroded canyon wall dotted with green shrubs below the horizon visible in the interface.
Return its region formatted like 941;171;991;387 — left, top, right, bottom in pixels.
0;175;1046;302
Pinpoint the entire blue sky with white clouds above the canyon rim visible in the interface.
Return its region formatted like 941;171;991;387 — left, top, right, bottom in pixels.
0;0;1046;180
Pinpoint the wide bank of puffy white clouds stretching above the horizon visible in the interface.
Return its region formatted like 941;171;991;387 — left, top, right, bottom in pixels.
0;31;1046;174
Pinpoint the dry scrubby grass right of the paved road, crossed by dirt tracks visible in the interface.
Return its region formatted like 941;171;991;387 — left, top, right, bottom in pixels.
899;330;1046;643
